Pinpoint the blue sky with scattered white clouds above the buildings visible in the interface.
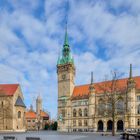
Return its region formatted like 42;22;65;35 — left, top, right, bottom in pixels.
0;0;140;118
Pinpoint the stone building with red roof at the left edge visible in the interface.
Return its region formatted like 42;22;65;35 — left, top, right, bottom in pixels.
0;84;26;131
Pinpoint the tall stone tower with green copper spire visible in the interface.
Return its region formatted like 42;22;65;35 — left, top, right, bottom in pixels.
57;28;75;131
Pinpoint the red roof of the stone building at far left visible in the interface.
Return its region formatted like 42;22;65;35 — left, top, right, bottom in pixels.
0;84;19;96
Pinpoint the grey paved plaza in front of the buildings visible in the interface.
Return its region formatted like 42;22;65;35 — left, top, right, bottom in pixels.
0;131;120;140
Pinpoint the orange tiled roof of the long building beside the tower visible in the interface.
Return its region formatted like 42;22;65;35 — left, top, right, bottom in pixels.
72;76;140;99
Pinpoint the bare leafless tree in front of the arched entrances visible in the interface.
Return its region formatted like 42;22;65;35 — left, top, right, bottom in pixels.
98;71;127;136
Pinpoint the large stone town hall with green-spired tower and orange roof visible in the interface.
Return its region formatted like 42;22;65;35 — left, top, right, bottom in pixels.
57;30;140;132
